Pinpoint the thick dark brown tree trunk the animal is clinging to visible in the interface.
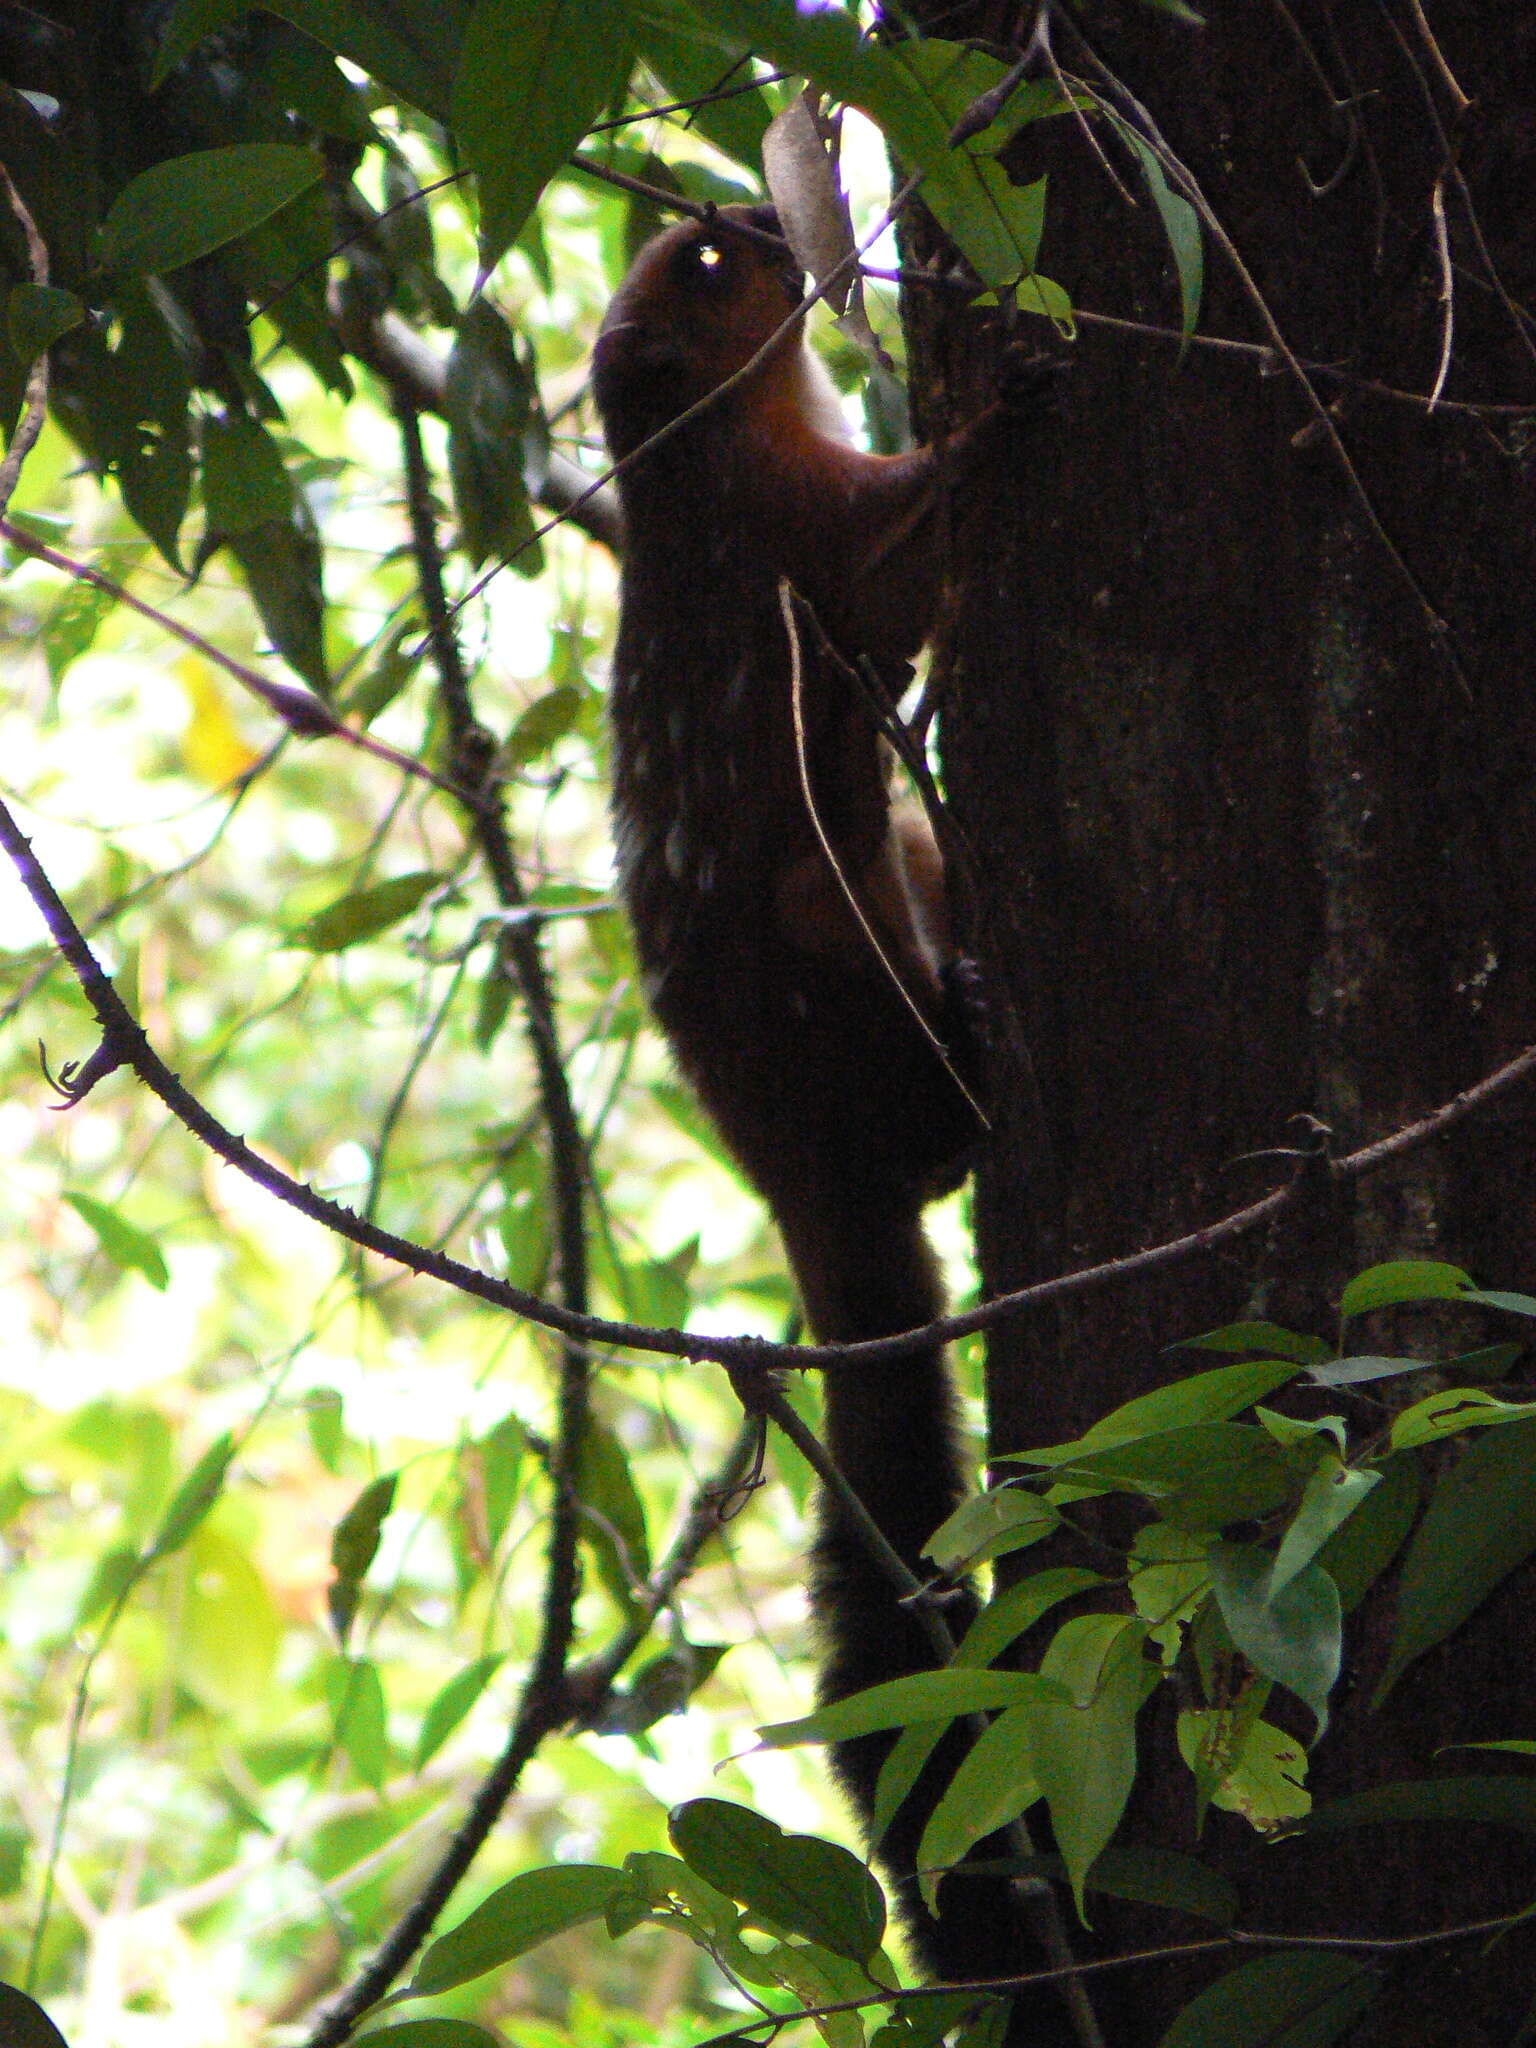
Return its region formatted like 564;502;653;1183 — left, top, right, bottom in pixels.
909;0;1536;2048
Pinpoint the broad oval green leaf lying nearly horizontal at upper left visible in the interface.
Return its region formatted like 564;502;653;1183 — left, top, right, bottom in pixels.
98;141;322;276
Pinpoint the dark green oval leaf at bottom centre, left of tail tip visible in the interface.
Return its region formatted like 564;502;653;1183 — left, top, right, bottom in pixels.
668;1798;885;1962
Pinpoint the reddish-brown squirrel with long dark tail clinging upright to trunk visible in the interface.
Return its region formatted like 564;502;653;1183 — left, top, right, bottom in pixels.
592;207;1067;2040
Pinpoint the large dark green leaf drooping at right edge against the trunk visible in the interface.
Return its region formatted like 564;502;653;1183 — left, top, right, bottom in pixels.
1372;1421;1536;1706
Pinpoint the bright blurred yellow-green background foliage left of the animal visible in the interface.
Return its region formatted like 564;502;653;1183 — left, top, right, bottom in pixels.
0;0;987;2048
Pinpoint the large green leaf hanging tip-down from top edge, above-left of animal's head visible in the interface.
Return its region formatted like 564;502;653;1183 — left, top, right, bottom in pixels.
453;0;631;270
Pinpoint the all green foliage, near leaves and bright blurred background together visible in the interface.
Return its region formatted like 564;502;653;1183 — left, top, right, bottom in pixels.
0;0;1536;2048
